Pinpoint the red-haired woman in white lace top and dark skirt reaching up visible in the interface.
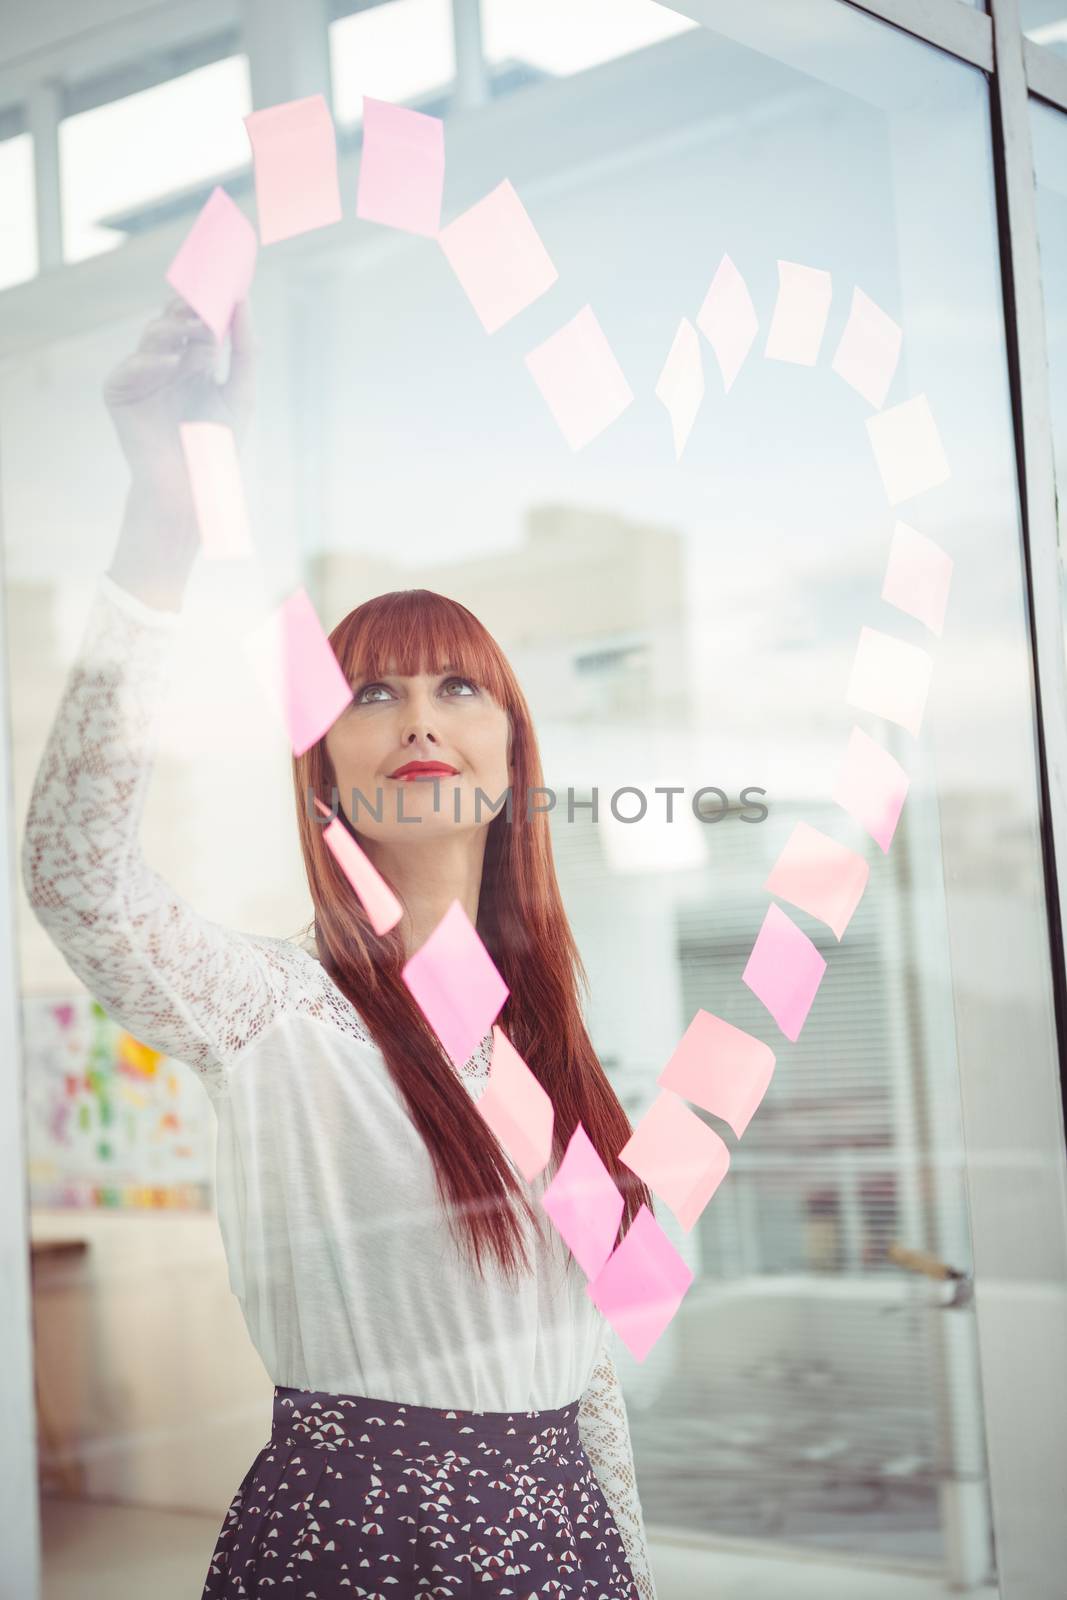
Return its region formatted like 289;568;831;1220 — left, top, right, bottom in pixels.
22;301;654;1600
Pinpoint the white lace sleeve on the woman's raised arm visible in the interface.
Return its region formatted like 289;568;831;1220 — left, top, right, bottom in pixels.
22;578;294;1099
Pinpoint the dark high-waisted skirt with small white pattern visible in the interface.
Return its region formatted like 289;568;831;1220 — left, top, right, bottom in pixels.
202;1387;638;1600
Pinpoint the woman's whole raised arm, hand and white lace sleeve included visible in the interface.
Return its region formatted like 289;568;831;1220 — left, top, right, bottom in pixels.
22;302;291;1096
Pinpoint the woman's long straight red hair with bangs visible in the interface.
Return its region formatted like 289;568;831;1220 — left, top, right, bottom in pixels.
293;589;651;1278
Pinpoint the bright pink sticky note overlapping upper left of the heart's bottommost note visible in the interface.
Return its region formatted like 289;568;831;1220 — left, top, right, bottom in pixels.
587;1205;693;1362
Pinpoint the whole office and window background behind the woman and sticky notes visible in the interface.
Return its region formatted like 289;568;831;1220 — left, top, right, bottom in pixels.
0;0;1067;1600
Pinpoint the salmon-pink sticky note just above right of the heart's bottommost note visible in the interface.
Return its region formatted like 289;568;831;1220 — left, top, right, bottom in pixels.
619;1090;729;1232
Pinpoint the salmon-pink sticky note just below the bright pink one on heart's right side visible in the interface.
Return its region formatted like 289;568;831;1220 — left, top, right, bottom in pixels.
656;1011;774;1138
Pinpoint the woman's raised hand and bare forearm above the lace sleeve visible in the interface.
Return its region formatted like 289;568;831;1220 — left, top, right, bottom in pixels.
104;299;254;610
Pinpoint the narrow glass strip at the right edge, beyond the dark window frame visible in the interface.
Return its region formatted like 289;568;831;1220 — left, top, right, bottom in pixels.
1030;101;1067;656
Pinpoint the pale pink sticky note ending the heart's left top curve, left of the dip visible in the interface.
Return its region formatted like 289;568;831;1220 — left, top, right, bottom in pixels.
526;306;633;450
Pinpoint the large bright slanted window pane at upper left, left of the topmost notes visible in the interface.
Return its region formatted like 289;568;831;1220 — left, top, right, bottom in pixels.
59;56;251;261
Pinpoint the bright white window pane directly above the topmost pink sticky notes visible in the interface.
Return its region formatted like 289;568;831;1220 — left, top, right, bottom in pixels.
330;0;456;125
